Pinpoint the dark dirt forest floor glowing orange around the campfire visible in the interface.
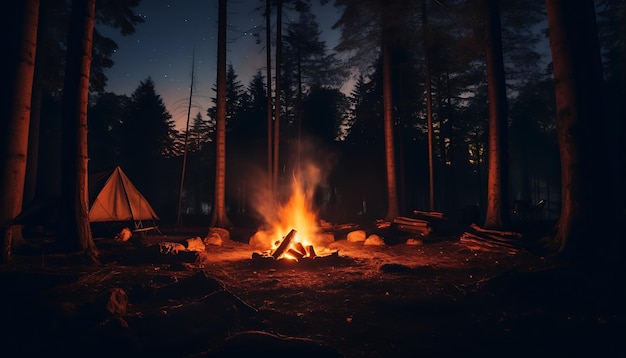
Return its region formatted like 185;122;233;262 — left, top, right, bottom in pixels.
0;222;626;357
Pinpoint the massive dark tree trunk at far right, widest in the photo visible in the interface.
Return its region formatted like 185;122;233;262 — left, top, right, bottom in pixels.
546;0;616;254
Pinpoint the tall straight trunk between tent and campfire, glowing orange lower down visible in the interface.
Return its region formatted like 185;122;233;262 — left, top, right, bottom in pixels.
211;0;232;229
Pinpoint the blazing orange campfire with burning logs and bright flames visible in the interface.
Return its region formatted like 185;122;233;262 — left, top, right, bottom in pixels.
250;166;337;261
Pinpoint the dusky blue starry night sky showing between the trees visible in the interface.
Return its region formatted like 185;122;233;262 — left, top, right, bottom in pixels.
98;0;339;130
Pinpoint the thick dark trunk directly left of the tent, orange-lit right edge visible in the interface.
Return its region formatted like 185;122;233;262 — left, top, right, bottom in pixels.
59;0;98;264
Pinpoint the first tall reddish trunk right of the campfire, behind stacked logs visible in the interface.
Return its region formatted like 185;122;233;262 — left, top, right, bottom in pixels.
382;40;400;220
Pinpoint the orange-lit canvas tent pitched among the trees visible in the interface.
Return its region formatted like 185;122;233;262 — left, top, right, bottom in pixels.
89;166;159;231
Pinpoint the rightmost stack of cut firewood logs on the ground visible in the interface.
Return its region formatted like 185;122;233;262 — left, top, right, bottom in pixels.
461;224;527;254
